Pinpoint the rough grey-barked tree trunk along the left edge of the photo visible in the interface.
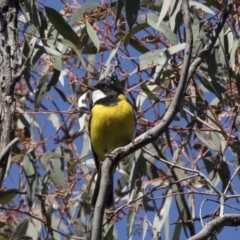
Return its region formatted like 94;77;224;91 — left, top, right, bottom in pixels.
0;0;18;187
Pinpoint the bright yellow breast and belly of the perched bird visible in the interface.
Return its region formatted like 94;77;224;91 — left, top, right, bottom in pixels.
90;95;136;161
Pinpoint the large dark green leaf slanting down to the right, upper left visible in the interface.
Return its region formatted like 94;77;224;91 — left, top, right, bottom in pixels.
45;6;80;46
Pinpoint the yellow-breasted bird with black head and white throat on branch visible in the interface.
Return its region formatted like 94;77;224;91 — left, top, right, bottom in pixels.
88;81;136;208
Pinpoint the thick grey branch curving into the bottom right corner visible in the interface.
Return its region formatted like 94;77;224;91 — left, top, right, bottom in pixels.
188;214;240;240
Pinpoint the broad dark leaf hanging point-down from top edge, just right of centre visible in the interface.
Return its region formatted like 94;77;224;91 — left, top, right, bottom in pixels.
125;0;140;31
